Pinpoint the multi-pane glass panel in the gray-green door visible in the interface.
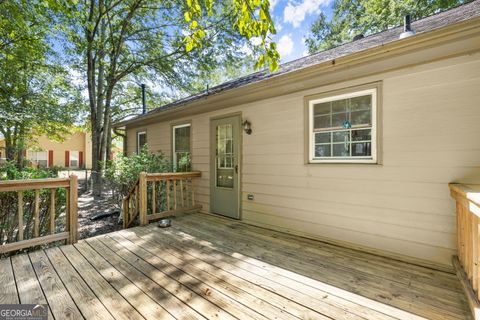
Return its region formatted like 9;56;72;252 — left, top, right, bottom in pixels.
216;124;235;189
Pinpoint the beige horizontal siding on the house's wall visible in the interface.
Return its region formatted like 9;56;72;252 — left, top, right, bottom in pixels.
128;53;480;265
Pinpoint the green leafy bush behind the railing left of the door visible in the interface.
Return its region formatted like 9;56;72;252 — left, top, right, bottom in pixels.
104;146;172;204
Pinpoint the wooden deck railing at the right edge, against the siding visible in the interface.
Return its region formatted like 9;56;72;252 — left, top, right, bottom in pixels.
450;184;480;319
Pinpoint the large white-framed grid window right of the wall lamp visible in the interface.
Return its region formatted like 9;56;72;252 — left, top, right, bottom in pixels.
308;88;377;163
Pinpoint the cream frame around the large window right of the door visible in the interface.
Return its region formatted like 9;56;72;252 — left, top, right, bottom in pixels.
306;84;379;164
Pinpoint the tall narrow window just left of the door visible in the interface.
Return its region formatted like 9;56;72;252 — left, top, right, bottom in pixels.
172;123;192;172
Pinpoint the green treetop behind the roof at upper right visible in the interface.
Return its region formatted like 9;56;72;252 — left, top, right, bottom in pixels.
305;0;469;53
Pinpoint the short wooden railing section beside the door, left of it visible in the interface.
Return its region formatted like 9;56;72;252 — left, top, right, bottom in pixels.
123;172;201;228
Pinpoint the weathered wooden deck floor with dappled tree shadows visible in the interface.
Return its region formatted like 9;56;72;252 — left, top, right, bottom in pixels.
0;214;469;320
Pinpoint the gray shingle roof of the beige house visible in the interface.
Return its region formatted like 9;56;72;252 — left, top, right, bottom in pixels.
125;0;480;122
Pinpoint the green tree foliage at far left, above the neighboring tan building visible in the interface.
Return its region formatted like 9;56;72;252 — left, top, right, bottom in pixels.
0;0;78;165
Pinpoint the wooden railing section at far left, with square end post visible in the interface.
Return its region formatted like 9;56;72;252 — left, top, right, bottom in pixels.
0;175;78;254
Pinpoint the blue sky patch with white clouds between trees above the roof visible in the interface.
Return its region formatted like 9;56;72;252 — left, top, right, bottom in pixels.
270;0;333;63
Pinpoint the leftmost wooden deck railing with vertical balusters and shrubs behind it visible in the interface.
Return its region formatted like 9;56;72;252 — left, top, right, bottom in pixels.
0;175;78;254
